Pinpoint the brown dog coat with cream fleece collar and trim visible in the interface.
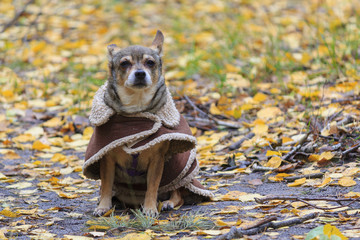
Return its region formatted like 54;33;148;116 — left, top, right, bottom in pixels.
83;83;213;204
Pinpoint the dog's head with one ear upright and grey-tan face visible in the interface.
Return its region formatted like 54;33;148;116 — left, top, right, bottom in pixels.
107;31;164;91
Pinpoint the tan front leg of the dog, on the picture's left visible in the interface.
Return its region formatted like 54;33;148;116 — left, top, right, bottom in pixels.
93;157;115;216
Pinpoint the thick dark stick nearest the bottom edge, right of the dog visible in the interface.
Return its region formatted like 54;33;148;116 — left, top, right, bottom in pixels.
217;213;317;240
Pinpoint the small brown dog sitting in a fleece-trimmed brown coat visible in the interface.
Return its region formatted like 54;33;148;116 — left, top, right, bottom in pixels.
83;31;212;216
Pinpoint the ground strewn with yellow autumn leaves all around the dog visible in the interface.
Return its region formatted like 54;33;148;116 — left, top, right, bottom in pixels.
0;0;360;239
